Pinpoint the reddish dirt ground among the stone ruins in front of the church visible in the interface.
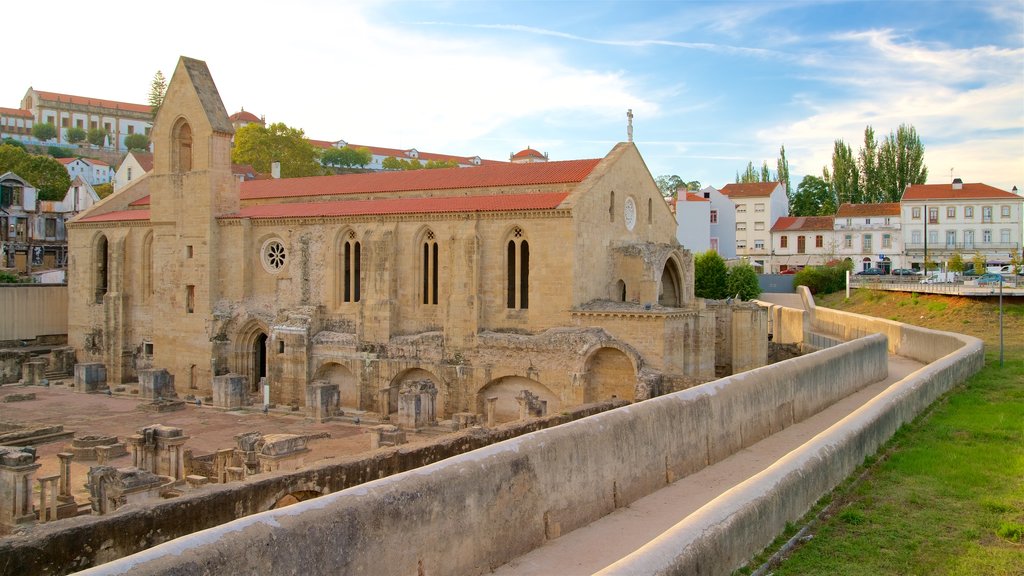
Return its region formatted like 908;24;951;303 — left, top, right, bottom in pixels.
0;380;434;502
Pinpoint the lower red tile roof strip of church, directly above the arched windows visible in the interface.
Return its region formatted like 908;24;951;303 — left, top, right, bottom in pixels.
225;192;568;218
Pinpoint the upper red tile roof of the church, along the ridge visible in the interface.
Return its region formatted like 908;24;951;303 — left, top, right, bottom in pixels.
242;159;601;200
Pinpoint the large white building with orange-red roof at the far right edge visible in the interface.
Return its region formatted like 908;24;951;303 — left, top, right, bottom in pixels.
900;178;1024;268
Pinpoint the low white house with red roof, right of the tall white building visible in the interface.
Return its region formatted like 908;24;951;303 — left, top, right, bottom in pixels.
768;216;836;273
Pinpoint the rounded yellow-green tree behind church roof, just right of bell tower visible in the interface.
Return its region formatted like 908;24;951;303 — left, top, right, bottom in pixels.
231;122;324;178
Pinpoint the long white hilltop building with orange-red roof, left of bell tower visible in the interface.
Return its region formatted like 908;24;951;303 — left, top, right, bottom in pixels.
22;87;153;150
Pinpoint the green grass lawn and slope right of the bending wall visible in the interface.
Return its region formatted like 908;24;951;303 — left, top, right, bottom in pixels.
741;290;1024;576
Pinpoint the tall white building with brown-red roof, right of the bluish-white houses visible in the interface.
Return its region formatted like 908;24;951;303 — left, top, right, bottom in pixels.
722;182;790;272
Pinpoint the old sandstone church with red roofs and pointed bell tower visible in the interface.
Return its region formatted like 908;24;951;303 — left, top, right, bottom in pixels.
69;57;767;421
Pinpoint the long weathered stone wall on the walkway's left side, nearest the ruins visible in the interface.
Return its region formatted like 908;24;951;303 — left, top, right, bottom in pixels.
75;335;888;574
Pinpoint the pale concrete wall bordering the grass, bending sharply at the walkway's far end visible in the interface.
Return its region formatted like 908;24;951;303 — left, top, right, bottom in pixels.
601;284;984;575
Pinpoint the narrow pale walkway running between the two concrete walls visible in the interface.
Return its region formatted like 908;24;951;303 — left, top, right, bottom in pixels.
494;356;924;576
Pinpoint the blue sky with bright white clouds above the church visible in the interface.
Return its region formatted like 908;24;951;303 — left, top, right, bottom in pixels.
6;0;1024;190
